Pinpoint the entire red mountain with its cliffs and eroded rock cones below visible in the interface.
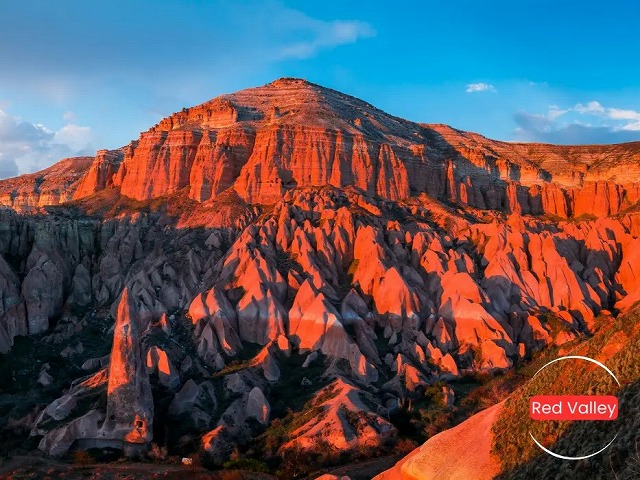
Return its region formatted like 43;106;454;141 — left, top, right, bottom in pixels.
0;79;640;478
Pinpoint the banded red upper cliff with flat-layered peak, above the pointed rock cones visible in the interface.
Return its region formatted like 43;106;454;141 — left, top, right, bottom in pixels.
5;79;640;218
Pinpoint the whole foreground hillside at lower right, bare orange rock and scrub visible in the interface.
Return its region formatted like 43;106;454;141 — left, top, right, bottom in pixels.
375;300;640;480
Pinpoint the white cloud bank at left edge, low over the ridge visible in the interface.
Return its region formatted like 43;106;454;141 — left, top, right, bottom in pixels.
0;110;95;178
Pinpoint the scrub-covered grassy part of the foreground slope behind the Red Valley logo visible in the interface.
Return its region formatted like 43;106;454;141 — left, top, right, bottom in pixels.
493;308;640;479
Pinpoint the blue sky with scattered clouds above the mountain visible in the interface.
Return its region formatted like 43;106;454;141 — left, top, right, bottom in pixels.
0;0;640;178
